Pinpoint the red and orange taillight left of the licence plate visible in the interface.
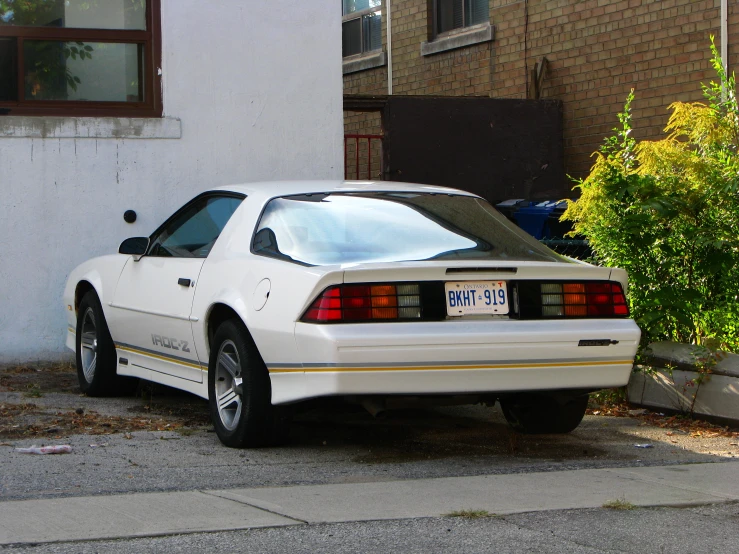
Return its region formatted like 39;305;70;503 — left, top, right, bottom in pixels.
301;283;421;323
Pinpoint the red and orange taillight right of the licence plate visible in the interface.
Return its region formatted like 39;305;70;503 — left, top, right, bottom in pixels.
541;282;629;317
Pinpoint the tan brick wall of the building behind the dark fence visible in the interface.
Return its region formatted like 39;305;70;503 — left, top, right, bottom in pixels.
344;0;739;185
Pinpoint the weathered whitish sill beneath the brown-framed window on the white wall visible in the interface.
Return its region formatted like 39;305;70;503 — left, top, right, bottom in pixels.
0;115;182;139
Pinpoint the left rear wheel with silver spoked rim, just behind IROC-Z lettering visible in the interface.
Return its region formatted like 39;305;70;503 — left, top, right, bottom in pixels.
208;320;290;448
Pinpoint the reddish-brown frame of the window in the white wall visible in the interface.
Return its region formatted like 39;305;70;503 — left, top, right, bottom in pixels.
0;0;163;117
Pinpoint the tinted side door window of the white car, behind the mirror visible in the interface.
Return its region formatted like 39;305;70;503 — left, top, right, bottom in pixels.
149;196;242;258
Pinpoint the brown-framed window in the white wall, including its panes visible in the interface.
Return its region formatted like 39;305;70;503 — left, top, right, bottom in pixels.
0;0;162;117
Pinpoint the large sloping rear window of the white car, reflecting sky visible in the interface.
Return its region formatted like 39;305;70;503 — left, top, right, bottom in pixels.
252;192;569;265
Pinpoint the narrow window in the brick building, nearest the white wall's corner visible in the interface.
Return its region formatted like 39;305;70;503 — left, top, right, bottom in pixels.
341;0;382;57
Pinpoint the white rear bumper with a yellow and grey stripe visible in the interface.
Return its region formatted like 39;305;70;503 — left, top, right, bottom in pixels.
267;320;640;404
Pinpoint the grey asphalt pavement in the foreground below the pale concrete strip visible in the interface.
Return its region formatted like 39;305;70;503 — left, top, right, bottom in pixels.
0;503;739;554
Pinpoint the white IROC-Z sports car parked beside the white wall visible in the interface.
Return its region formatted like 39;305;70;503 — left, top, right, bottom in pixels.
64;181;640;447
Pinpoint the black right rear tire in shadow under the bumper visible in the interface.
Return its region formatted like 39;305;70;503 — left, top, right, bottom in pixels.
500;393;588;435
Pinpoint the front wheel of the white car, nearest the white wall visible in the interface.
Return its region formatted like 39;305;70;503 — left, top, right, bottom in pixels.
76;290;138;396
